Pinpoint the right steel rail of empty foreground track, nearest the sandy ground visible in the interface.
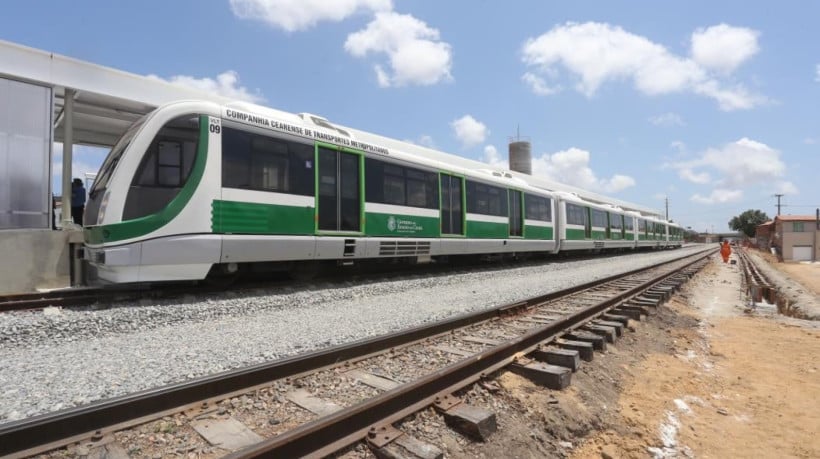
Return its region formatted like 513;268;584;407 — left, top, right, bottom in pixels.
226;254;711;459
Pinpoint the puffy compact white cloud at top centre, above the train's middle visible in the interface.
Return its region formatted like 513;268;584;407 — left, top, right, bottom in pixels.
345;12;453;87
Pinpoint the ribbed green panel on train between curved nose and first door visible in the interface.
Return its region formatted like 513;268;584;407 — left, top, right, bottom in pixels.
211;200;315;234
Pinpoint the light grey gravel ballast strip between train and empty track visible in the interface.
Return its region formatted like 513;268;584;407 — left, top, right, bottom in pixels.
0;246;711;423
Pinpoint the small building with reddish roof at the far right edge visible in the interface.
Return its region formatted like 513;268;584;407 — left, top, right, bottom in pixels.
772;215;820;261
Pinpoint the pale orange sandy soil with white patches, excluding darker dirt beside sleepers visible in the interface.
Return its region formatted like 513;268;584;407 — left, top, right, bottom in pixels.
573;256;820;458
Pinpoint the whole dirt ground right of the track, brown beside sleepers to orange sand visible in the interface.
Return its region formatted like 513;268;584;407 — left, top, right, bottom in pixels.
419;257;820;459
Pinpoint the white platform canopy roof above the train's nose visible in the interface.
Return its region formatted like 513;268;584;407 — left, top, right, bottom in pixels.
0;40;231;146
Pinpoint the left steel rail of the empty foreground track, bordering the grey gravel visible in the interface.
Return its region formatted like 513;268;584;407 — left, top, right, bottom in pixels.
0;250;714;456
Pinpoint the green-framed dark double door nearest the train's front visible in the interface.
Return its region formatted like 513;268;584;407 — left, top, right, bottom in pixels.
316;146;362;233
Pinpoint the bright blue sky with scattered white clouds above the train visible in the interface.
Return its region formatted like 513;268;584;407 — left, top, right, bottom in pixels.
0;0;820;231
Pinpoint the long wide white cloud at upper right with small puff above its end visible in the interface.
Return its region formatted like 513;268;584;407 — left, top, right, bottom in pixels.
523;22;766;111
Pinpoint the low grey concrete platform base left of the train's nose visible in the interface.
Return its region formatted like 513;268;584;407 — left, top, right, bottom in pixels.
0;227;83;294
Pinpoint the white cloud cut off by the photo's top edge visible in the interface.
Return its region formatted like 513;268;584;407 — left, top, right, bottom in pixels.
230;0;393;32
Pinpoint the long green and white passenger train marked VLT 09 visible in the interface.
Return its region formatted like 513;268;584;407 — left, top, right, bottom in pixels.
84;101;683;284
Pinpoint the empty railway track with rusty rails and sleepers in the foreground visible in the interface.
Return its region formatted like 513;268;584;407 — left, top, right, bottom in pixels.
0;251;714;457
